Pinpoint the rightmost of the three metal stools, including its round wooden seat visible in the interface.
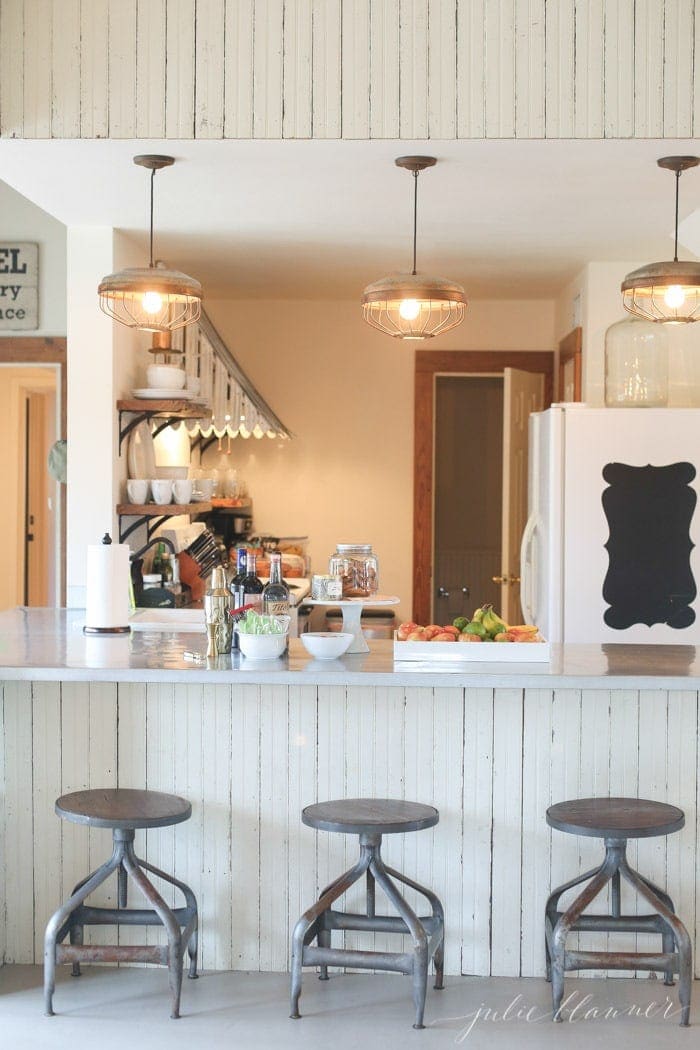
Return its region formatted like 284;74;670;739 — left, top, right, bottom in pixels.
545;798;693;1025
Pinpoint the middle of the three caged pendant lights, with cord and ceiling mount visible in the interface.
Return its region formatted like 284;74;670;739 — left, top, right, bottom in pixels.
362;156;467;339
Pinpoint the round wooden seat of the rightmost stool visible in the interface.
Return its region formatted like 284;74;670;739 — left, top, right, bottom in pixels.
547;798;685;839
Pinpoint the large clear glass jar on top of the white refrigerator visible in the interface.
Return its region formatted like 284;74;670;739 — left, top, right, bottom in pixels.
606;317;669;408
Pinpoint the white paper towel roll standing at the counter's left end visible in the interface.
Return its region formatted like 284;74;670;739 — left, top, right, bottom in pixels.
85;533;130;631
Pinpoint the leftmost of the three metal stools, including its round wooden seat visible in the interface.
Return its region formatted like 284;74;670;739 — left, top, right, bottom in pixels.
44;788;197;1017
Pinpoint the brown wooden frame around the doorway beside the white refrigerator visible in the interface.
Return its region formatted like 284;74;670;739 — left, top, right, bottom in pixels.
412;350;554;624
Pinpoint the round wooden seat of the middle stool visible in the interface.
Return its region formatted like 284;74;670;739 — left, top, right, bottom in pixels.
301;798;440;835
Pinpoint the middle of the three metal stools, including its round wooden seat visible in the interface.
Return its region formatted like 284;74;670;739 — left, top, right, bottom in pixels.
291;798;445;1028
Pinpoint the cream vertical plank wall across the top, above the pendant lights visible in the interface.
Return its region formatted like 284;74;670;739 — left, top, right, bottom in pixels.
0;0;700;139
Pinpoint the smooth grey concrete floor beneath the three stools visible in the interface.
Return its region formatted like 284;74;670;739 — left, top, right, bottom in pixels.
0;966;700;1050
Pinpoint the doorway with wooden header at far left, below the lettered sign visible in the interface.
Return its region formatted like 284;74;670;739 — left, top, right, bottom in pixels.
0;338;66;608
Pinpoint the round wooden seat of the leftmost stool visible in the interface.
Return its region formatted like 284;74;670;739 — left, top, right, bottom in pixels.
56;788;192;828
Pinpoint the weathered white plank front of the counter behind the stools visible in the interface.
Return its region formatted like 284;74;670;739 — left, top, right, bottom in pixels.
0;681;700;977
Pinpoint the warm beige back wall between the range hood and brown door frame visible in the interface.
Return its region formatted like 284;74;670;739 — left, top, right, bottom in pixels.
199;300;554;616
